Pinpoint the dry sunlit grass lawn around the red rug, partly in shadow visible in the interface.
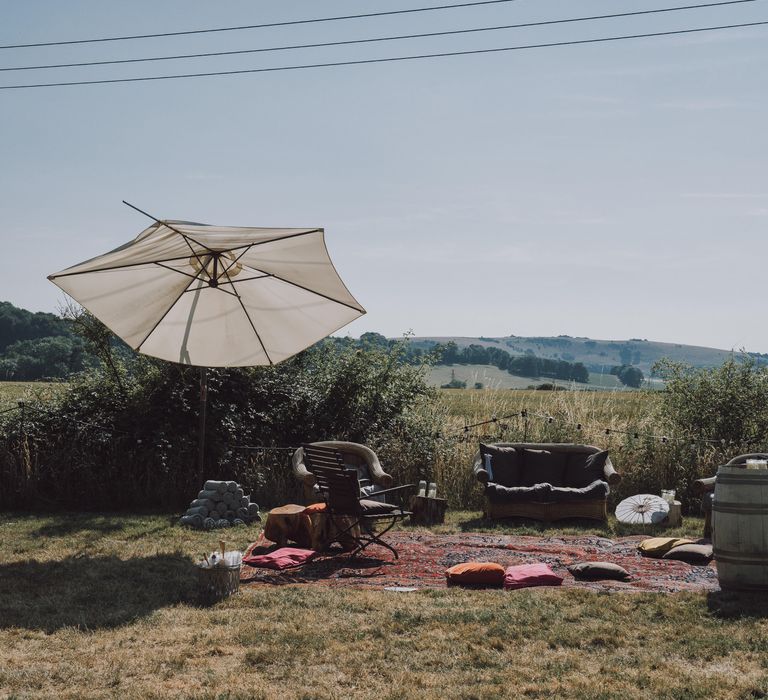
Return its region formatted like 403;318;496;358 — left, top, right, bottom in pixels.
0;512;768;700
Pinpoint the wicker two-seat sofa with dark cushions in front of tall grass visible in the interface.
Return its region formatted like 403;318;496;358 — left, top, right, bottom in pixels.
473;442;621;520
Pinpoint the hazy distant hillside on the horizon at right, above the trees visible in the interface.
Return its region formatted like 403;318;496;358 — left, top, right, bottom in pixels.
402;335;768;383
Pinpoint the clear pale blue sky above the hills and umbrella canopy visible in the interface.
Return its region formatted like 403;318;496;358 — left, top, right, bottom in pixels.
0;0;768;352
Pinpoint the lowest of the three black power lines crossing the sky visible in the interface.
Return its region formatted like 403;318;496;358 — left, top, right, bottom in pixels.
0;20;768;90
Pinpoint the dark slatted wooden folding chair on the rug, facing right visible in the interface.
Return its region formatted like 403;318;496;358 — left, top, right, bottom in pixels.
302;445;414;559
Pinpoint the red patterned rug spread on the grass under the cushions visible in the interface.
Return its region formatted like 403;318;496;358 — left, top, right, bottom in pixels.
240;532;719;593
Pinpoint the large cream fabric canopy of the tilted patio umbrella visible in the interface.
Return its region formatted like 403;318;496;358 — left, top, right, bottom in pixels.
48;215;365;367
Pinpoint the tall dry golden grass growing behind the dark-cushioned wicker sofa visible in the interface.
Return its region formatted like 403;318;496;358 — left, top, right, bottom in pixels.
434;389;739;511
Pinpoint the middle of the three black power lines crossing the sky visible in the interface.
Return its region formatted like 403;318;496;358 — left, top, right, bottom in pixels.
0;0;755;72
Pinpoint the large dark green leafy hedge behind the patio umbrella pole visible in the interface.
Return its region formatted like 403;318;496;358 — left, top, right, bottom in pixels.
0;342;440;510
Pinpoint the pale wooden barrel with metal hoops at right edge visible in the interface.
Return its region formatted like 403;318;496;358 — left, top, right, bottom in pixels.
712;466;768;590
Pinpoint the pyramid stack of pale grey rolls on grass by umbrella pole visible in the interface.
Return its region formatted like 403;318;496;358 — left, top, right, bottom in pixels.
179;481;261;530
